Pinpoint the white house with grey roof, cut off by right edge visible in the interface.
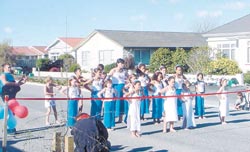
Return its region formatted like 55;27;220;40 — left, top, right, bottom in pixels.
203;14;250;72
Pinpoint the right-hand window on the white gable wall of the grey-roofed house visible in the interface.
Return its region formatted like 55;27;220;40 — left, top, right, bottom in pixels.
99;50;114;65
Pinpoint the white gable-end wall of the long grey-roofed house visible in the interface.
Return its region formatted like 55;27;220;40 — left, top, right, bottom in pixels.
76;32;124;71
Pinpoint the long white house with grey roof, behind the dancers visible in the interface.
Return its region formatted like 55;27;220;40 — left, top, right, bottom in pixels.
75;30;206;70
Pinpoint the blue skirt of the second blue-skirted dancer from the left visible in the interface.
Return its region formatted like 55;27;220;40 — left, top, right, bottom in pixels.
90;91;102;120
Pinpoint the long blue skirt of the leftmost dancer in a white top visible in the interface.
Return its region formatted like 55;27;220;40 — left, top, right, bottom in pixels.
66;100;78;127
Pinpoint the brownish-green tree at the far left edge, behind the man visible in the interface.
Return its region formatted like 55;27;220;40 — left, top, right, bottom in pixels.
0;41;15;65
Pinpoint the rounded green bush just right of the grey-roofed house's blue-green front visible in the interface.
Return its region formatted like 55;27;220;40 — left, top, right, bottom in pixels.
149;48;173;71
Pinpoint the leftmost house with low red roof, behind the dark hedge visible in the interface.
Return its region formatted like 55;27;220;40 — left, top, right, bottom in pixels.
12;46;48;68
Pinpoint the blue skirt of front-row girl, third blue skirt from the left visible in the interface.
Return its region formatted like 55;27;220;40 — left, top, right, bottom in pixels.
103;101;115;128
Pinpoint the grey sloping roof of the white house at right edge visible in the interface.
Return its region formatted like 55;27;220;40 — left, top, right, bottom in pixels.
205;14;250;35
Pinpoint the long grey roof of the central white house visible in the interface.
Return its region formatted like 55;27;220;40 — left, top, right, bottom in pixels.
96;30;207;47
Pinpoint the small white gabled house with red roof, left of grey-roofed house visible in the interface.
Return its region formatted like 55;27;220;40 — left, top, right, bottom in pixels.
45;37;83;61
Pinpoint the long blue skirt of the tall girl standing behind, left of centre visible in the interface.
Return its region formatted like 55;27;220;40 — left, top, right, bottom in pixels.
113;84;125;117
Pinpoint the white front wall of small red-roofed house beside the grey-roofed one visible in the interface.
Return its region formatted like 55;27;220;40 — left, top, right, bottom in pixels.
48;41;75;60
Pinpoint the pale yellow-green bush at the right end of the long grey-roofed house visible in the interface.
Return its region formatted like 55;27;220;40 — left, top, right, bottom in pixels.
186;46;211;74
